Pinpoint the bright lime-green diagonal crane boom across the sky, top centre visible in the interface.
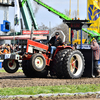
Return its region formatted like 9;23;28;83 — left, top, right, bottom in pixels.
34;0;71;20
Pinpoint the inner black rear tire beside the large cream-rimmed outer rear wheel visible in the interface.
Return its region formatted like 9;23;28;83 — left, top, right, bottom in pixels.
53;49;72;78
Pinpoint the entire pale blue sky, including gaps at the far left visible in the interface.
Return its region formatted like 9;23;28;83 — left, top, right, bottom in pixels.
0;0;87;28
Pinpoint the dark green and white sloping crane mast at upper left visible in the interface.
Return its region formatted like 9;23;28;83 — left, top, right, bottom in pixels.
20;0;38;30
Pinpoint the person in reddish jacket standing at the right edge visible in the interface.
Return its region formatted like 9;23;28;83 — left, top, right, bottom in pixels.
91;39;100;77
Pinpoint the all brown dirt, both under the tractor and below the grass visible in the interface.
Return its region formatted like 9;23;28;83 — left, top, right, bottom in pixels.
0;72;100;100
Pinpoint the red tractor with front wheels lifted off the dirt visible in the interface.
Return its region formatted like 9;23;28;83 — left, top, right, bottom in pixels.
1;40;85;78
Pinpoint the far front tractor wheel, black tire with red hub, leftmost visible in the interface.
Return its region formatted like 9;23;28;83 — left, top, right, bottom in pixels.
3;59;19;73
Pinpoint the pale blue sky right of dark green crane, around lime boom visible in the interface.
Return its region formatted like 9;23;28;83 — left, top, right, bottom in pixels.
32;0;87;27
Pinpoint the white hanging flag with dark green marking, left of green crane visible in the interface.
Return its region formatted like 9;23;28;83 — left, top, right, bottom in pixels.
14;0;20;31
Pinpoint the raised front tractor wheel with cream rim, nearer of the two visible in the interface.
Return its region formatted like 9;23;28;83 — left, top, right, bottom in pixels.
30;53;46;72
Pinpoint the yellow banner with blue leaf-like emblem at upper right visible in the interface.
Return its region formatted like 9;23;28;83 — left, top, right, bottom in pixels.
87;0;100;33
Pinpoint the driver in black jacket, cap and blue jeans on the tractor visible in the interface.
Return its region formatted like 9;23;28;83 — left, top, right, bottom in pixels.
49;32;63;58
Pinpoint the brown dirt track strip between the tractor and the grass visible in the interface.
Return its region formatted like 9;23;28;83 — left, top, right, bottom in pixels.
0;72;100;88
